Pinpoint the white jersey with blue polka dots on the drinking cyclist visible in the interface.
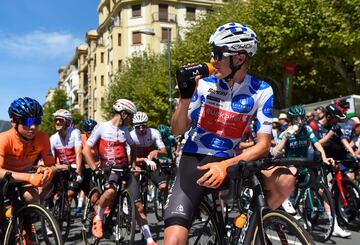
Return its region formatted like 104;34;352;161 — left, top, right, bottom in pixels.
183;73;273;157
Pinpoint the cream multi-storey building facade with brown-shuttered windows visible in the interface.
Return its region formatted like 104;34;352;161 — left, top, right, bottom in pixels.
57;0;223;121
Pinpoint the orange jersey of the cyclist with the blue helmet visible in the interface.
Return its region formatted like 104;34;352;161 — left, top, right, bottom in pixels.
0;128;55;172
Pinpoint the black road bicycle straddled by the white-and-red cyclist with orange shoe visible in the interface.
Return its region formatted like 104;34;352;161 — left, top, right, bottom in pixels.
81;166;143;244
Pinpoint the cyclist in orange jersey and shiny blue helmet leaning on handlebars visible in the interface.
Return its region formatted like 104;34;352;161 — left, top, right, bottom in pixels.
0;97;56;203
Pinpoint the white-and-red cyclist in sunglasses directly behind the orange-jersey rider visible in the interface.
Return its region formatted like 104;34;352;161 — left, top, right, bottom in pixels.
50;109;82;203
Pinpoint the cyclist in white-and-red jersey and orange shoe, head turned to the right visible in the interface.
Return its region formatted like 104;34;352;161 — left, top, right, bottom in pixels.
83;99;156;244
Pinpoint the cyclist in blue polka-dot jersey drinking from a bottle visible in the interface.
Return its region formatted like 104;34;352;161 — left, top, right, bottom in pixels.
164;23;278;245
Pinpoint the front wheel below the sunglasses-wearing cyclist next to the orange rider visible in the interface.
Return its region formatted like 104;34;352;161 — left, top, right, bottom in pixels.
44;195;71;242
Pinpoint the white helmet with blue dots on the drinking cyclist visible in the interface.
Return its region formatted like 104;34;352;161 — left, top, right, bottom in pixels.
209;22;257;57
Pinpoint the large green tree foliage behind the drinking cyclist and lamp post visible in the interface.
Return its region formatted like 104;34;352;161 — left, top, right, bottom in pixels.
107;0;360;113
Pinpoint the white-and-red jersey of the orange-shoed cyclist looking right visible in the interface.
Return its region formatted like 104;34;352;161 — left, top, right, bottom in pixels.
86;121;134;166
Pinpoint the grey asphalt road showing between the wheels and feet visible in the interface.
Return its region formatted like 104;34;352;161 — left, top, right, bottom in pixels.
62;203;360;245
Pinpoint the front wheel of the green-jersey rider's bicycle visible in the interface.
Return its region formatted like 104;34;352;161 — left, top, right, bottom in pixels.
302;183;335;243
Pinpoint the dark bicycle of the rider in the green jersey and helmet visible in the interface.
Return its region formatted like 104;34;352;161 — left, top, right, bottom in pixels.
294;168;335;243
